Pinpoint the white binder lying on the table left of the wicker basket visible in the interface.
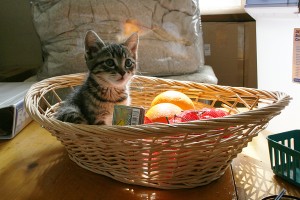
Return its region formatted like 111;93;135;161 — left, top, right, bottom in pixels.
0;82;33;139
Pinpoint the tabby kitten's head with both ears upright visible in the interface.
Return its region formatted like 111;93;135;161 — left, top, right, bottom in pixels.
85;31;139;87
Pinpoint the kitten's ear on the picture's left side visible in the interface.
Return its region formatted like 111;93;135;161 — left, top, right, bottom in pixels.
84;31;105;59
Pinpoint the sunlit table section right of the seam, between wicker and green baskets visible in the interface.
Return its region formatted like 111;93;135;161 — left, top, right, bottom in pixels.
232;129;300;200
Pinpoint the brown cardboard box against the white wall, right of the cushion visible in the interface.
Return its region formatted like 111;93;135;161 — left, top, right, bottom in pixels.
202;22;257;88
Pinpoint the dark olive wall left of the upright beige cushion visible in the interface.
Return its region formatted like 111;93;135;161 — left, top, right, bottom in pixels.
0;0;42;80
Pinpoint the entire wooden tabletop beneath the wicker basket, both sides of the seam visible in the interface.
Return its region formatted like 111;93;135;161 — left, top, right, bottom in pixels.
0;122;300;200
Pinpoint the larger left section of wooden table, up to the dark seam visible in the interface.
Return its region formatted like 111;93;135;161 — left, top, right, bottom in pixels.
0;122;237;200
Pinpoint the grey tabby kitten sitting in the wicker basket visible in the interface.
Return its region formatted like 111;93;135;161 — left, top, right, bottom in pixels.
54;31;139;125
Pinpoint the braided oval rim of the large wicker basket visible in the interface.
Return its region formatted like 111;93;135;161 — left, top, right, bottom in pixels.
25;73;292;138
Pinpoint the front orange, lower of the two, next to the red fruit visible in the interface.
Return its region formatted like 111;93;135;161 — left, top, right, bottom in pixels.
145;103;182;123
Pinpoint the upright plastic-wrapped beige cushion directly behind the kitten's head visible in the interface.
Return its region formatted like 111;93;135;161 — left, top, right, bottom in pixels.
32;0;204;79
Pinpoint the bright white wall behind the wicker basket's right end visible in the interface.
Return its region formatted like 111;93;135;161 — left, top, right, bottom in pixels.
248;6;300;133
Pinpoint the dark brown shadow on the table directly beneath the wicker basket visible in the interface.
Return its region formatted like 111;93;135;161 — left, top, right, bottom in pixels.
32;151;236;200
